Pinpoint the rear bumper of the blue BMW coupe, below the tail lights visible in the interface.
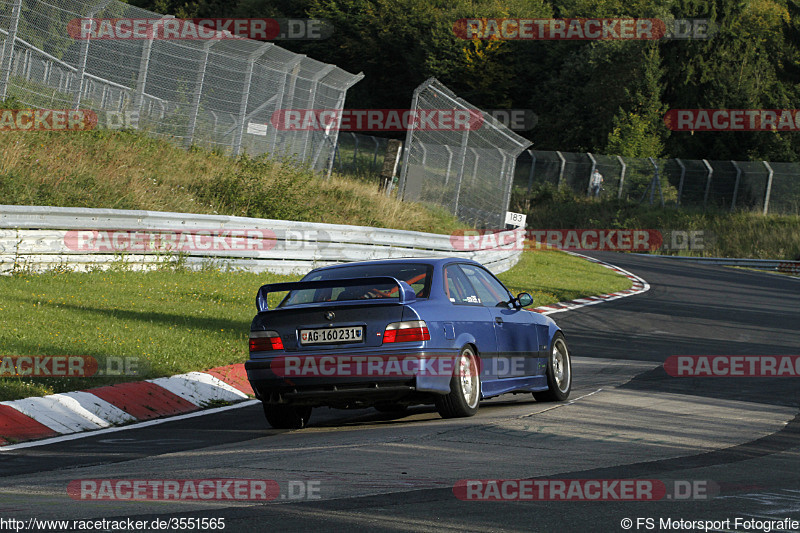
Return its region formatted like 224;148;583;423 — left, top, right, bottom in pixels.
245;351;458;407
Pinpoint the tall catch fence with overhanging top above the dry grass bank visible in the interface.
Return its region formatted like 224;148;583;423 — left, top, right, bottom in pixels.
0;0;363;170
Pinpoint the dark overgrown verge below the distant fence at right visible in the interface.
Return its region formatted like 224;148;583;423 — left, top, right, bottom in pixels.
512;189;800;260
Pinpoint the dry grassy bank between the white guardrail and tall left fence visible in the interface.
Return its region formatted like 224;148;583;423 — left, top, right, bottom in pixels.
0;130;464;233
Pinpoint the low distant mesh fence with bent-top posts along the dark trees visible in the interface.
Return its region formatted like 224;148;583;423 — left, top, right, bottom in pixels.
514;150;800;214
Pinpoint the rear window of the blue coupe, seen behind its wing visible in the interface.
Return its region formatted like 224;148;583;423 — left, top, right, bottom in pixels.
278;264;433;307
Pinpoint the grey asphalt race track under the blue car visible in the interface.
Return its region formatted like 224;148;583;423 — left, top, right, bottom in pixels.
0;253;800;532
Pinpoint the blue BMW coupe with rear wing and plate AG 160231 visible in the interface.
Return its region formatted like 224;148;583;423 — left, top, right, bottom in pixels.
245;258;572;428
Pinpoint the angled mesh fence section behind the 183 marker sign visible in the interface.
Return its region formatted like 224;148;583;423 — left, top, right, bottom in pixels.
398;78;531;228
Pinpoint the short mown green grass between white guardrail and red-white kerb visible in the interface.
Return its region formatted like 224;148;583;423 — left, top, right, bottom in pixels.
0;250;630;400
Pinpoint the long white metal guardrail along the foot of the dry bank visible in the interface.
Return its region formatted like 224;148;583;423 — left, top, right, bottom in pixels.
0;205;522;274
